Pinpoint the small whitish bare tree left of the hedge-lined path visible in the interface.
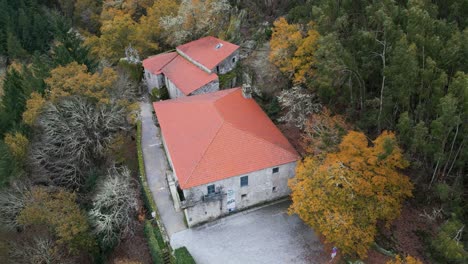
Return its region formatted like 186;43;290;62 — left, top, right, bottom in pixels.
89;166;138;246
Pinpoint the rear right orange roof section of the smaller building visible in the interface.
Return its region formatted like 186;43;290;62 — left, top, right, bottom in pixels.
177;36;239;70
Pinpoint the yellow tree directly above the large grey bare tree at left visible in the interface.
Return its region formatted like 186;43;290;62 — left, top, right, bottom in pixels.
46;62;117;103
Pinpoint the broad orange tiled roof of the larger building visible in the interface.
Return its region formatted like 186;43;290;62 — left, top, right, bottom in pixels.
154;88;299;189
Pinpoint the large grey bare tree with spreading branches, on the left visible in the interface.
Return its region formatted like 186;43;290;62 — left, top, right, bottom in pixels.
30;97;129;189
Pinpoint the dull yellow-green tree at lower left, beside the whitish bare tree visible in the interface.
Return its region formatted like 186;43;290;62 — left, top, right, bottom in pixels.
18;187;96;253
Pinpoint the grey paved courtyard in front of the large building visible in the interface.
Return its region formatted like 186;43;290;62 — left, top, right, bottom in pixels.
171;201;328;264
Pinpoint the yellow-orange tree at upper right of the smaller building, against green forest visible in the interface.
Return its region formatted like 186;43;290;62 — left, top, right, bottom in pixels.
269;17;320;84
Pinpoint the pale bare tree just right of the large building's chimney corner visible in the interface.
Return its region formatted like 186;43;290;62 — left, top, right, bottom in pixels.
278;86;322;129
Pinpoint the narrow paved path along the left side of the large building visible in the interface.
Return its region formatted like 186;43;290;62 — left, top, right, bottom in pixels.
140;101;187;237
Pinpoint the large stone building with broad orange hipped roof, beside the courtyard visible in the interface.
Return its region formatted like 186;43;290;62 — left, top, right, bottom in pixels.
154;87;299;226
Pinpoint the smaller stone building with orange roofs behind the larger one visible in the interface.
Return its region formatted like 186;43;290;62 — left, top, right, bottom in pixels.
143;36;239;98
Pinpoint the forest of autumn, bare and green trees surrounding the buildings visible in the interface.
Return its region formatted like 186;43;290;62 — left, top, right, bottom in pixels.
0;0;468;263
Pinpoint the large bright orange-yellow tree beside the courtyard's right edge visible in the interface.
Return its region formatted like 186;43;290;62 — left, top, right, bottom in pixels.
289;131;413;258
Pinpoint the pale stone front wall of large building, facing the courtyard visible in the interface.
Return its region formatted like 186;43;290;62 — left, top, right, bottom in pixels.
180;162;296;227
